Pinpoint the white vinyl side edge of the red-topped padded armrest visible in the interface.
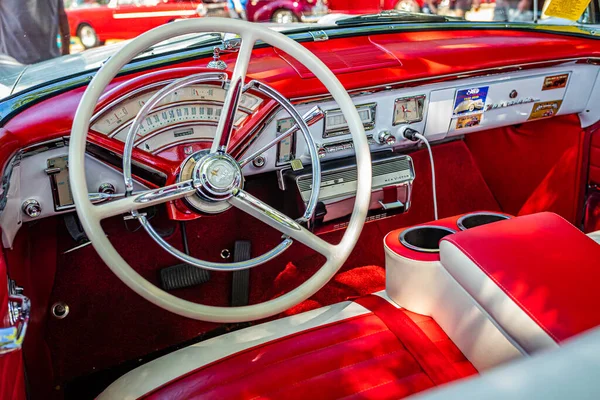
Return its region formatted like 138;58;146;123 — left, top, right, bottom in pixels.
440;240;558;354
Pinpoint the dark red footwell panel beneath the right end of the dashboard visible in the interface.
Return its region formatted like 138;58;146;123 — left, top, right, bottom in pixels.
465;115;584;223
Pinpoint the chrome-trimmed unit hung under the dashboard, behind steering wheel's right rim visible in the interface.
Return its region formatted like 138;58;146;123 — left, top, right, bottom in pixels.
283;152;415;233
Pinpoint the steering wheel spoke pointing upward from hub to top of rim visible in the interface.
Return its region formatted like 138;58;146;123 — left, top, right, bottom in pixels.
210;35;256;153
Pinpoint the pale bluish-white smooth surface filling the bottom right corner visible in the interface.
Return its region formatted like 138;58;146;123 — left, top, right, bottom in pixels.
411;328;600;400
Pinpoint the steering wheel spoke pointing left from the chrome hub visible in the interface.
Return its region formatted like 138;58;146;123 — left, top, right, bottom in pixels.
93;179;196;220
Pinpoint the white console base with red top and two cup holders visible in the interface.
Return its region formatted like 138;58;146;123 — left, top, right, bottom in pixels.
384;212;522;371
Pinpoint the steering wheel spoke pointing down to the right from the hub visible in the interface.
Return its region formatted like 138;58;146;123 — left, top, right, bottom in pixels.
229;190;334;259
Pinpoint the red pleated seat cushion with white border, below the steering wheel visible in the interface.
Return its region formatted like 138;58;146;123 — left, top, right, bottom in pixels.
143;295;477;399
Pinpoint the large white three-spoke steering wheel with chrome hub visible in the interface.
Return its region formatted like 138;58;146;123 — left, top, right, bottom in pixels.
69;18;371;323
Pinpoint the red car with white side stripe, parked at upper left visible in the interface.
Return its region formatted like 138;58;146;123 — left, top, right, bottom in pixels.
66;0;206;48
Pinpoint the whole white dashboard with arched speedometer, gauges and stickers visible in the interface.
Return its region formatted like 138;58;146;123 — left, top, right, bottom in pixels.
0;57;600;246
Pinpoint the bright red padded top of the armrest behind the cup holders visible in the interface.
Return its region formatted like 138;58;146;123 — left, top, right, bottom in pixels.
442;212;600;342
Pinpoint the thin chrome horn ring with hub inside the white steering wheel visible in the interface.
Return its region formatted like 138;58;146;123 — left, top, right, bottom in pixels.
118;72;322;271
